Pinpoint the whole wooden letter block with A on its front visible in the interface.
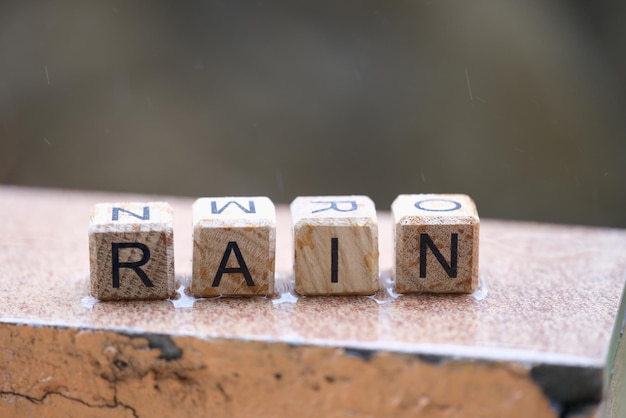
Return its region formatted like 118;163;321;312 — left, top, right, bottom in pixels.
191;197;276;297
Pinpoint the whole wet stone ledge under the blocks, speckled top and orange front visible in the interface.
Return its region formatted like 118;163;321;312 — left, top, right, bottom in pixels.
0;186;626;417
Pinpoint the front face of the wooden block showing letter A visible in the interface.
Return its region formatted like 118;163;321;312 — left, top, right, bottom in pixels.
190;225;276;297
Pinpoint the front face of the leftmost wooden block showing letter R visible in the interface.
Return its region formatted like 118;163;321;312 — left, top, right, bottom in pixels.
89;228;176;301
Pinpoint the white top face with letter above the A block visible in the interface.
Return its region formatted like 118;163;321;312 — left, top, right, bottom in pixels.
192;196;276;227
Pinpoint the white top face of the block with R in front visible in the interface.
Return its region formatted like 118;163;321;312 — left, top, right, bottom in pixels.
89;202;174;232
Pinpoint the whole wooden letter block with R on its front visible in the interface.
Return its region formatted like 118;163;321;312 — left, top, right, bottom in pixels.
89;202;176;300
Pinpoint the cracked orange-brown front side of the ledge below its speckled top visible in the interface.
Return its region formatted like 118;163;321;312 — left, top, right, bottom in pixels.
0;325;554;417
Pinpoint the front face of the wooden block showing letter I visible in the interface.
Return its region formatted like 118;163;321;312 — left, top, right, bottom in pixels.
294;222;379;296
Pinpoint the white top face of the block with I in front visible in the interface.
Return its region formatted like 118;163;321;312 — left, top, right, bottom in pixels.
291;196;378;225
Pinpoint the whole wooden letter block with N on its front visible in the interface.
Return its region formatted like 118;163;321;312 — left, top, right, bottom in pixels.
391;194;480;293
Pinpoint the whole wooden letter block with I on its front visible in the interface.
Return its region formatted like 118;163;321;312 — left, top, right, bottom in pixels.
291;196;379;296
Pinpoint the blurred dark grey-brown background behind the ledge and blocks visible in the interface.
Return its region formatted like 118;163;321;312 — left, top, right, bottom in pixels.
0;0;626;227
